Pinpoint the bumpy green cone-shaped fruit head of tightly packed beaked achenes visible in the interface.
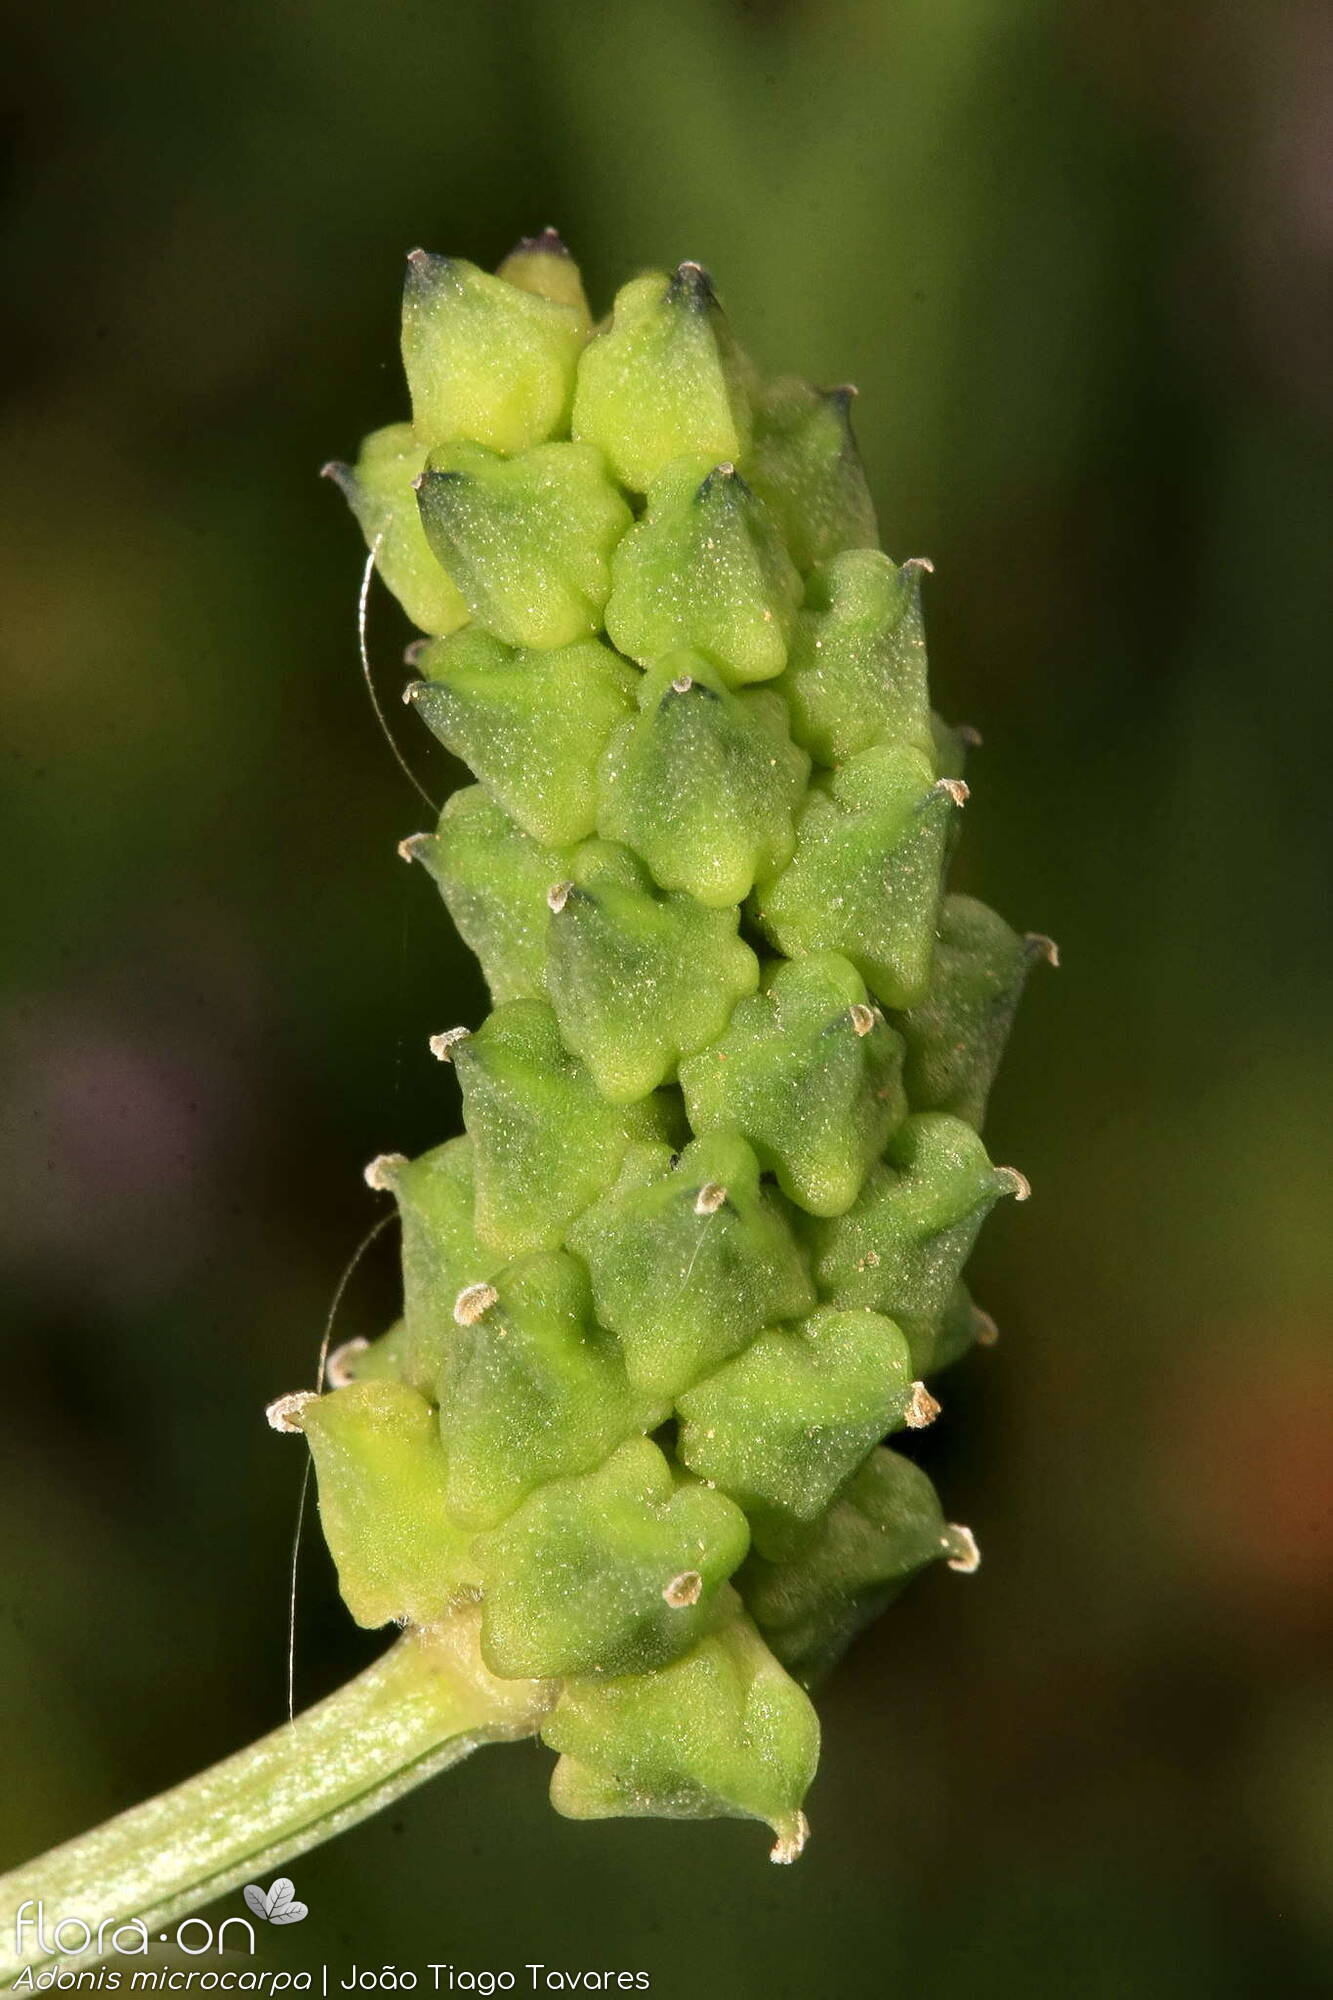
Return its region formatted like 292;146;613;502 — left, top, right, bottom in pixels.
306;232;1053;1860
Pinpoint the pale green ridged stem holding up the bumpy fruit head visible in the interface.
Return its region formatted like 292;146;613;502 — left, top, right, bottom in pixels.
0;1608;552;1990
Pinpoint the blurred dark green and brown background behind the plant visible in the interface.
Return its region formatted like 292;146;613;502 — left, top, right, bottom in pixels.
0;0;1333;2000
